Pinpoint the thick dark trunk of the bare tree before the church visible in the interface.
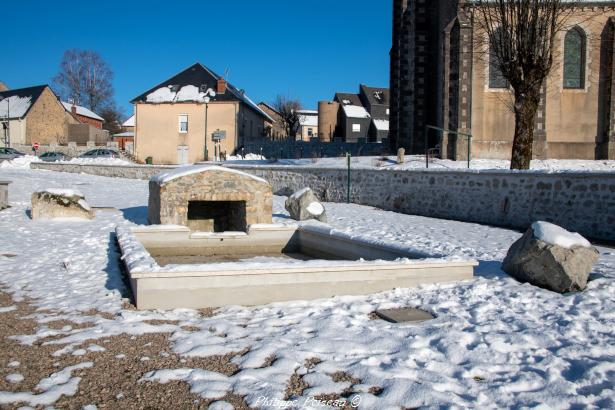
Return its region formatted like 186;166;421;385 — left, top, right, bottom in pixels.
510;90;540;169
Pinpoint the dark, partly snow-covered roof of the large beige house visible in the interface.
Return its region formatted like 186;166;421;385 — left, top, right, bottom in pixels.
131;63;274;121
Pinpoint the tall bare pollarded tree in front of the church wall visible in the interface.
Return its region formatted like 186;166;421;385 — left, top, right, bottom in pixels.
475;0;573;169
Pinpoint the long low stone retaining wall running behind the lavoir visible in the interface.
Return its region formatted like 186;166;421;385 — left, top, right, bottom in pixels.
32;164;615;240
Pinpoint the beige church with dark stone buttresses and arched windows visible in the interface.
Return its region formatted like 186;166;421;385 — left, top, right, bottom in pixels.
391;0;615;159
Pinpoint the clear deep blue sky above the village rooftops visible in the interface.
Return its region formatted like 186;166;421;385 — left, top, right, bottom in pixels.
0;0;392;118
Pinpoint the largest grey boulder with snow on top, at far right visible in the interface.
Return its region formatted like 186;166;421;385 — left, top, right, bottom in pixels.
502;222;599;293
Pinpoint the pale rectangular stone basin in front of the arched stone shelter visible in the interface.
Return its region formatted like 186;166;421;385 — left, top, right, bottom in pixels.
117;225;477;309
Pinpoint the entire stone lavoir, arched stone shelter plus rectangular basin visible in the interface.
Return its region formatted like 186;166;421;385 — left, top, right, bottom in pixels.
116;165;477;309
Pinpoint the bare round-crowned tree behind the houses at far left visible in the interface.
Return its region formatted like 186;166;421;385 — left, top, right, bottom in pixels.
53;49;113;111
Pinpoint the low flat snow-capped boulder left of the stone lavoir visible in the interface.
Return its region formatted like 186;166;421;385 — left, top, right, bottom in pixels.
32;189;94;219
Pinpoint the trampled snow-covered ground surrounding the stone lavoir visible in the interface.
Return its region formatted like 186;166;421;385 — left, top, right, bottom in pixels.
0;168;615;409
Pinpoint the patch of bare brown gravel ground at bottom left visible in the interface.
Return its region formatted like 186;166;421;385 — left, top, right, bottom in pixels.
0;291;248;410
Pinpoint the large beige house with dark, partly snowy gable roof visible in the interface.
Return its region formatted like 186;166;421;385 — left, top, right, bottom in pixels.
132;63;271;164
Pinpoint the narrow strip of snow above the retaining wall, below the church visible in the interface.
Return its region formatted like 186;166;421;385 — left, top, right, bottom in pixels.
226;155;615;172
